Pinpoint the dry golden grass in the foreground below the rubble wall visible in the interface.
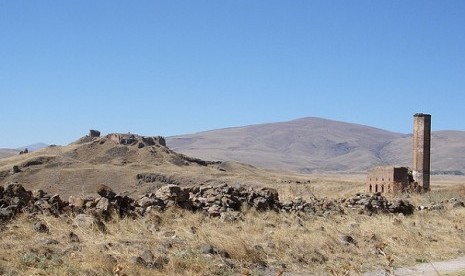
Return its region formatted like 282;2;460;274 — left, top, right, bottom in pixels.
0;190;465;275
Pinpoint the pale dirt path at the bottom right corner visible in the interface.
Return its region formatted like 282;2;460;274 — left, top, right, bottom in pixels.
364;257;465;276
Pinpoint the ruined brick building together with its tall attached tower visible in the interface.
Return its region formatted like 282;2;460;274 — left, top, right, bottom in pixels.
366;113;431;193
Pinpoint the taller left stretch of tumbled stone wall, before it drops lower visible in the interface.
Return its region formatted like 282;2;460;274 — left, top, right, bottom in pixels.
0;184;280;221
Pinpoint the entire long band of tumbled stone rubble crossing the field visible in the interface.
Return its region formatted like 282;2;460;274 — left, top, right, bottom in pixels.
0;183;454;225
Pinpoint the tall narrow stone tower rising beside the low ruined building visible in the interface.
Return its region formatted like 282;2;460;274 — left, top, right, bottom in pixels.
412;113;431;191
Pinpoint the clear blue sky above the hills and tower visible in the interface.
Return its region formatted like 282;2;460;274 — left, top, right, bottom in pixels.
0;0;465;147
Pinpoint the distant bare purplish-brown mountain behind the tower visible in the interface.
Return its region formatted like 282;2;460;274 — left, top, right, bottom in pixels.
167;117;465;173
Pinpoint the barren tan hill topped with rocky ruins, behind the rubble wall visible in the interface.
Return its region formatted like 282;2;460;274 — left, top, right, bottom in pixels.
0;134;316;198
